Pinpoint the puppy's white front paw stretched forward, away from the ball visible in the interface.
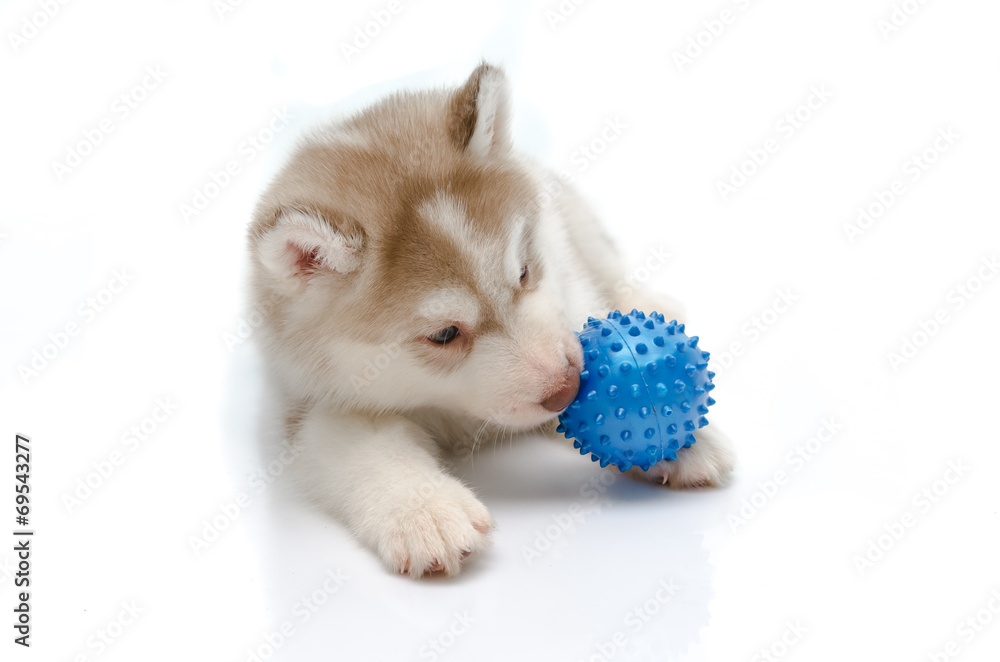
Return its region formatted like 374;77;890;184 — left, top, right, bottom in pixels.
376;476;493;578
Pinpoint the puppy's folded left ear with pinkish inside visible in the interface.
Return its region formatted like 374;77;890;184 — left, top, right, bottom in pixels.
257;209;364;289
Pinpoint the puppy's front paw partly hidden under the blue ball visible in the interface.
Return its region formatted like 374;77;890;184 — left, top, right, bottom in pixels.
628;426;736;490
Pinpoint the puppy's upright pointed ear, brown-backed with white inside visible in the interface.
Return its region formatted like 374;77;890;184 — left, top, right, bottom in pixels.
448;62;510;157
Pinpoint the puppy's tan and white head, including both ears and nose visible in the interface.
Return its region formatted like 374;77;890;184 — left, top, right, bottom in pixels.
251;64;582;428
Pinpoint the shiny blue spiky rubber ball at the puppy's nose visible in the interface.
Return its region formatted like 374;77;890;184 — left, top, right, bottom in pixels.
557;310;715;471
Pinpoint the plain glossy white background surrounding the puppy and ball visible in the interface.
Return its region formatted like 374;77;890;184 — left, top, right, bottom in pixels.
0;0;1000;662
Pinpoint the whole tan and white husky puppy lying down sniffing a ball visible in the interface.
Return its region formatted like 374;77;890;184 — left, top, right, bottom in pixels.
249;63;733;577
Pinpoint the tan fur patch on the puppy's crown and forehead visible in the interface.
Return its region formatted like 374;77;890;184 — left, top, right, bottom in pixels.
251;75;538;348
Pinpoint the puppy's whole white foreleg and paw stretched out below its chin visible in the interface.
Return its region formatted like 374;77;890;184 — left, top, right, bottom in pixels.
298;407;493;577
